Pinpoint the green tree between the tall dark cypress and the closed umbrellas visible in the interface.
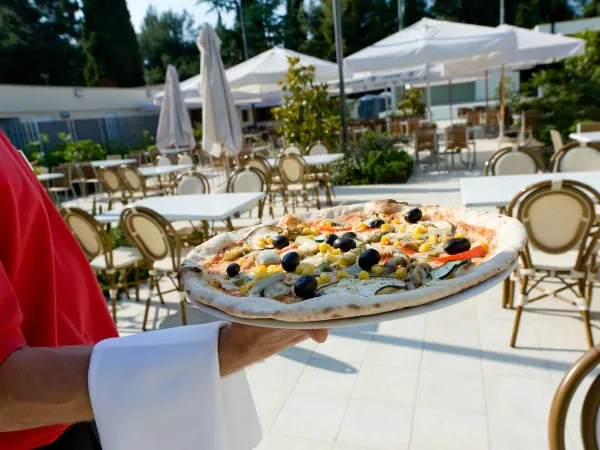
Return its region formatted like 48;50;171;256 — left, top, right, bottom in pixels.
138;6;200;84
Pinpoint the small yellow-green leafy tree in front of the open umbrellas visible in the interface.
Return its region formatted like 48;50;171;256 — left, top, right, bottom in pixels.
272;58;340;148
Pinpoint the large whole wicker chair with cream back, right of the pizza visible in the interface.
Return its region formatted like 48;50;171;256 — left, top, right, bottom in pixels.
503;180;600;347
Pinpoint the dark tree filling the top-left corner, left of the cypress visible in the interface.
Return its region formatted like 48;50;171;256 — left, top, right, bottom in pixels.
0;0;85;86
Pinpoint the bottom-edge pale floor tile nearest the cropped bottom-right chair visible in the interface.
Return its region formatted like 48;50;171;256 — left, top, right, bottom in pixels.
488;417;548;450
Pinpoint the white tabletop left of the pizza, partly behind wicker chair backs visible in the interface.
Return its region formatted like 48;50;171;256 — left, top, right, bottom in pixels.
96;192;265;228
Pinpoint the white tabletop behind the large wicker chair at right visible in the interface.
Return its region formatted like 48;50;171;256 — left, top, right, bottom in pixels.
460;172;600;207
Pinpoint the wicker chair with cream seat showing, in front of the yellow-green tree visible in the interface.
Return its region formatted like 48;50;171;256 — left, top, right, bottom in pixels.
277;154;321;212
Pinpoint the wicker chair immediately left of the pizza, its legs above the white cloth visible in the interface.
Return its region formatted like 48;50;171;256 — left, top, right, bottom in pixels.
121;206;192;331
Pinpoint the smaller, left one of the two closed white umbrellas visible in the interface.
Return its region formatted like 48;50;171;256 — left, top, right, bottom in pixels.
156;65;196;150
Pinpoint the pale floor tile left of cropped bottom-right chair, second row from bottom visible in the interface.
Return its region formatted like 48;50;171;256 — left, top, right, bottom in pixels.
485;376;555;420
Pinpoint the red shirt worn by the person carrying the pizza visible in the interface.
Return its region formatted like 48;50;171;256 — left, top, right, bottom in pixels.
0;131;118;449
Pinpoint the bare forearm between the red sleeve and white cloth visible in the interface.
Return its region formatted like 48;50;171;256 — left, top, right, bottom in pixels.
0;346;93;432
